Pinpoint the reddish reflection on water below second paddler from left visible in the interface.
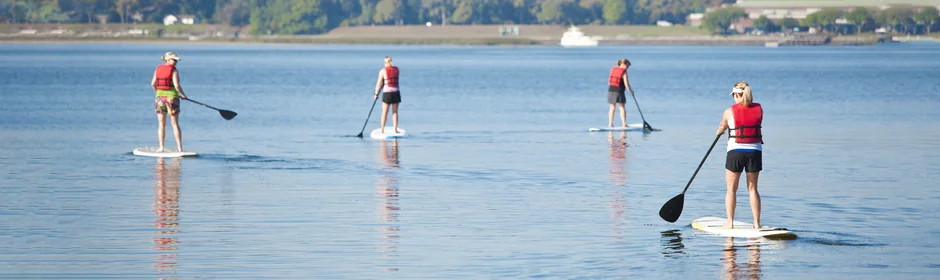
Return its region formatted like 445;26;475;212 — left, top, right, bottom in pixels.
376;139;401;271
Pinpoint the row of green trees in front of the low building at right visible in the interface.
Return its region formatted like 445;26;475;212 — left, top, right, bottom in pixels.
702;6;940;34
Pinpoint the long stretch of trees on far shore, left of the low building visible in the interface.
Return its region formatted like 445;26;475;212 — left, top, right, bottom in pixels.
0;0;733;34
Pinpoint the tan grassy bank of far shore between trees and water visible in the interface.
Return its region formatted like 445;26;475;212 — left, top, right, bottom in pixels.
0;24;904;46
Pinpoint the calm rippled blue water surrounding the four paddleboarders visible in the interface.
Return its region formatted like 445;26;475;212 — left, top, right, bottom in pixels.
0;44;940;279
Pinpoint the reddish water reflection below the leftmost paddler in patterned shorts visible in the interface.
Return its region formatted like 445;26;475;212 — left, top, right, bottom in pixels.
153;158;181;279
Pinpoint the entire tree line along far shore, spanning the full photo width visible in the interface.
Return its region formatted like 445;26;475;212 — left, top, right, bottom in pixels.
0;0;938;34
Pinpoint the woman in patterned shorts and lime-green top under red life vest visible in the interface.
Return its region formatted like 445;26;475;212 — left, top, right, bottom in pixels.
150;52;186;152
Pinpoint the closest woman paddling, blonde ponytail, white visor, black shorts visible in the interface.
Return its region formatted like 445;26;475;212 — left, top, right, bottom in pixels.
718;81;764;228
